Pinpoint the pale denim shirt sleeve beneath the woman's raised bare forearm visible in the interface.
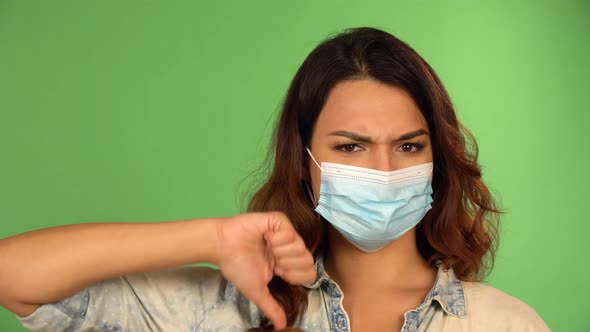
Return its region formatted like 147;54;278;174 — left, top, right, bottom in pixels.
17;266;227;332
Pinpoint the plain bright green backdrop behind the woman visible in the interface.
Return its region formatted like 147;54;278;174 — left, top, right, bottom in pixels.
0;0;590;331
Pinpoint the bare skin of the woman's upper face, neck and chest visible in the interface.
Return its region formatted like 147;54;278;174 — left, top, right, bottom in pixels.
309;80;436;331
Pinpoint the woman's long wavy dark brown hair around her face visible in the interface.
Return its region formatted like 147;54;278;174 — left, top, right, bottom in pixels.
248;27;499;325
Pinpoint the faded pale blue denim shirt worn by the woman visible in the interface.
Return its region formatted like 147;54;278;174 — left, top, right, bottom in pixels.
17;259;549;332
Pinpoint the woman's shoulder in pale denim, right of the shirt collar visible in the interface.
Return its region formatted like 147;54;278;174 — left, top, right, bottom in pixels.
462;282;549;331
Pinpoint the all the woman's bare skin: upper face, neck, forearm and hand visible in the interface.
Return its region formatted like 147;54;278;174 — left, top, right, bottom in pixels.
0;80;436;331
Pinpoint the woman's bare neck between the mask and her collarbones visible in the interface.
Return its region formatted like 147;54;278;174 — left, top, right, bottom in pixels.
324;226;436;293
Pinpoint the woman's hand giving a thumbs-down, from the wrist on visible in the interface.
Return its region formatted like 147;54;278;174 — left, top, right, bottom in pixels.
215;212;316;329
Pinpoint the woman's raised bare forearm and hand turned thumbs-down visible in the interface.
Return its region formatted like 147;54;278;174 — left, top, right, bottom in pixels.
0;212;316;329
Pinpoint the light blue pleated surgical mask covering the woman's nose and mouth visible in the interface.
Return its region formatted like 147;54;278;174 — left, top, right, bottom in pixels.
307;149;433;253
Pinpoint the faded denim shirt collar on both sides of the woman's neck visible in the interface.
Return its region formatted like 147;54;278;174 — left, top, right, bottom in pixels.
304;255;467;317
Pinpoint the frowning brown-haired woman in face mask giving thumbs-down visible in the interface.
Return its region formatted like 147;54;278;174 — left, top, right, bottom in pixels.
0;28;548;331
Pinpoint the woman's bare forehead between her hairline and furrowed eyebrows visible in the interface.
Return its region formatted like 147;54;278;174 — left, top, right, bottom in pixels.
314;79;428;137
